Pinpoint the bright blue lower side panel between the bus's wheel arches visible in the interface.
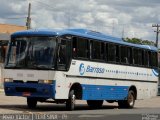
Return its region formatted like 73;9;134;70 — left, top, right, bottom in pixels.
82;85;129;100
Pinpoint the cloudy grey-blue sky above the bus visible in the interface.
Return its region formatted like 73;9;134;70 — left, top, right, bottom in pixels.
0;0;160;41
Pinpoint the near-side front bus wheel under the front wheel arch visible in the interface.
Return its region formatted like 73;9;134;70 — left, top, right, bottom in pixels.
66;90;76;111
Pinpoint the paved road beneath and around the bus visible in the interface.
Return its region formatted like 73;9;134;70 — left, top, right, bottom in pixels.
0;93;160;120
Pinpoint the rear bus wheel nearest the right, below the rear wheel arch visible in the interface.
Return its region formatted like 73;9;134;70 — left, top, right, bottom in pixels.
118;90;136;109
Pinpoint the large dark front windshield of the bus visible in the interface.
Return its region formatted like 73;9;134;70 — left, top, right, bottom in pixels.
5;37;56;69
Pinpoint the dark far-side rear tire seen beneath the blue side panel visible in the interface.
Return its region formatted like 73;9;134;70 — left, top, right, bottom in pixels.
87;100;103;109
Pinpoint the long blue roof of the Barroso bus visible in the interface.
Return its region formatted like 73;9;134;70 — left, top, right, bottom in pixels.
11;29;158;51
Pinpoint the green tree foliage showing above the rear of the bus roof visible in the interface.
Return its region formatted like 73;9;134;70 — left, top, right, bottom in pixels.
124;38;155;46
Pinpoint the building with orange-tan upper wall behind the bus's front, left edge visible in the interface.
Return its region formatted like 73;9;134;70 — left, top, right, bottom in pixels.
0;24;26;88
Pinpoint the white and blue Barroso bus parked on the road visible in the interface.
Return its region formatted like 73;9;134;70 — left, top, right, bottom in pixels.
4;29;158;110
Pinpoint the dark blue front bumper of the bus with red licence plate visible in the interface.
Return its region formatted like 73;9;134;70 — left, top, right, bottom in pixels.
4;81;56;98
